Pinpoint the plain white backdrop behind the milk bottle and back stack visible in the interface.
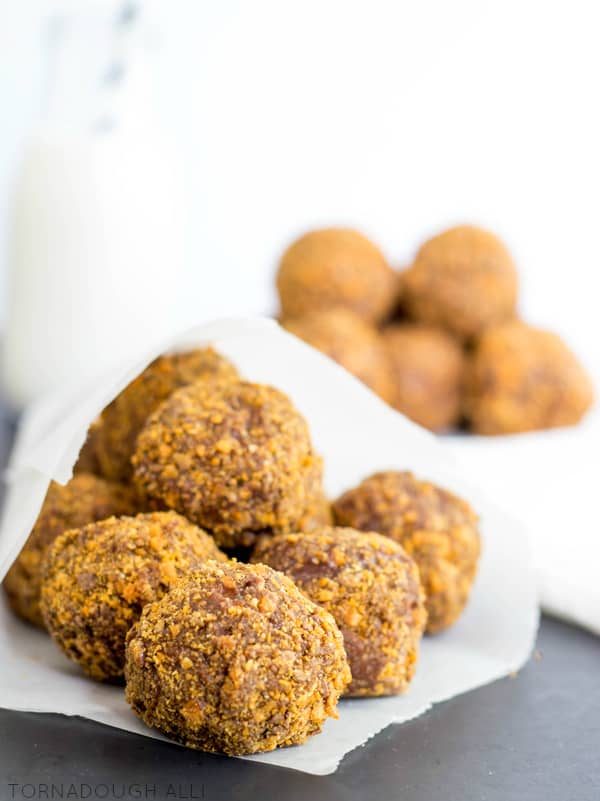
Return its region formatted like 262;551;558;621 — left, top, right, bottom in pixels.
0;0;600;375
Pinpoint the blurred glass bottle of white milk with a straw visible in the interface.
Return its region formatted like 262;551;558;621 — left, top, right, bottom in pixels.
3;2;184;409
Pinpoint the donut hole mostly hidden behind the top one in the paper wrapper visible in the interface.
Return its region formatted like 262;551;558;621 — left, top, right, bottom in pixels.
96;348;238;481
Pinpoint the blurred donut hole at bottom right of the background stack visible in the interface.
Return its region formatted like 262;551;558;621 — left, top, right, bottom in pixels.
465;320;594;434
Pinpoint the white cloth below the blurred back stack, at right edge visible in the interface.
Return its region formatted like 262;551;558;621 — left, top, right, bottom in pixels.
446;410;600;634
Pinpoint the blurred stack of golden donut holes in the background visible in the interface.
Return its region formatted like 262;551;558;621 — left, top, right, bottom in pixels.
276;225;593;435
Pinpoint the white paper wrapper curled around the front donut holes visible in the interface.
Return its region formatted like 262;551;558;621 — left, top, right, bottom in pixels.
0;320;538;774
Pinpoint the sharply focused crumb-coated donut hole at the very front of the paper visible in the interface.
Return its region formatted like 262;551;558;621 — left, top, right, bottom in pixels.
125;562;350;755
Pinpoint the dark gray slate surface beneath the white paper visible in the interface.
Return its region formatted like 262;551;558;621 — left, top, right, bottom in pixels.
0;619;600;801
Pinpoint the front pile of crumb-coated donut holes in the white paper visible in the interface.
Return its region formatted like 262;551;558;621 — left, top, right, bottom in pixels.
4;346;480;755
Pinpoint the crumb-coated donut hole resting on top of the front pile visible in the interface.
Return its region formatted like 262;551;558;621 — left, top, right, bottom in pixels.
133;381;322;548
